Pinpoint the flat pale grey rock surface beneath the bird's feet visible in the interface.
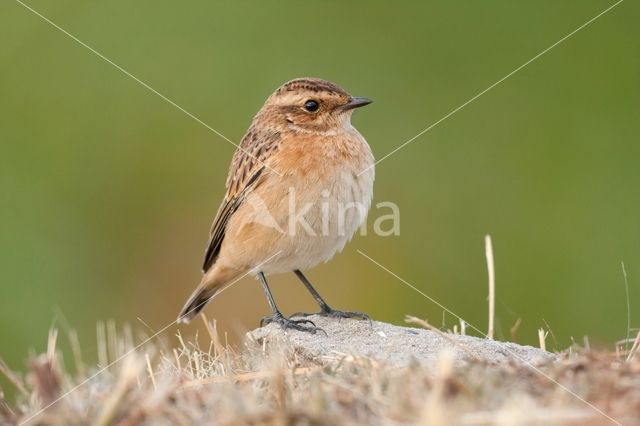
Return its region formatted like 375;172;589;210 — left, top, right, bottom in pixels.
248;315;556;368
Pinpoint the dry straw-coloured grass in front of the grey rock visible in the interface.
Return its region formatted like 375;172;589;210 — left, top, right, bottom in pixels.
0;325;640;426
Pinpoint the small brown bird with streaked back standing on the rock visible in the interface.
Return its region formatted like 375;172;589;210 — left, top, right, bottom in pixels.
178;78;374;332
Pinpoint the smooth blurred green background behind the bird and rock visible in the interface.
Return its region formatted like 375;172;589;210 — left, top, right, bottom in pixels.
0;0;640;386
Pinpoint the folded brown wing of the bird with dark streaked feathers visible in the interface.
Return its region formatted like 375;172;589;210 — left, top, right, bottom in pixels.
202;127;280;272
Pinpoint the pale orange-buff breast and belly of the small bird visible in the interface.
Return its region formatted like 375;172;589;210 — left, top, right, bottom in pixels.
221;129;374;274
